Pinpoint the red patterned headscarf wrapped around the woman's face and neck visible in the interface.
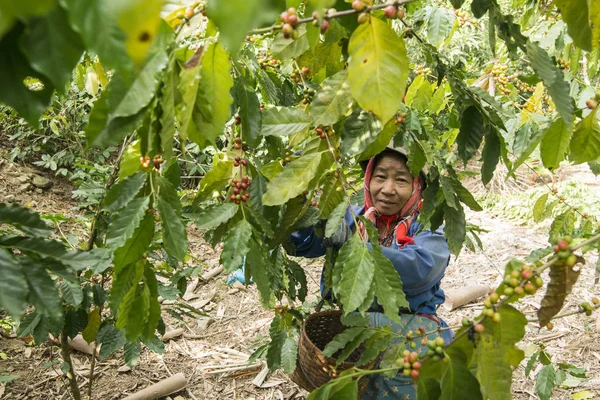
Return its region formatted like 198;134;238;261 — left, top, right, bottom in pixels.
359;156;425;248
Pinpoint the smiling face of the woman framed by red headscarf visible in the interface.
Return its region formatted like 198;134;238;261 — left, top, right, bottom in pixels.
369;155;413;215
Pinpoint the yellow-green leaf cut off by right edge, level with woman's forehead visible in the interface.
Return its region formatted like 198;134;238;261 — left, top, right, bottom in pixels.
569;107;600;164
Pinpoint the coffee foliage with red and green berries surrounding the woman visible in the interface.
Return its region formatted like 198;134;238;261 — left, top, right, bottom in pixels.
0;0;600;399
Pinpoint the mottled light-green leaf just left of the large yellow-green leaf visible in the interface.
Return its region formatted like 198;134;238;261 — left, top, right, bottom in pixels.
309;70;353;126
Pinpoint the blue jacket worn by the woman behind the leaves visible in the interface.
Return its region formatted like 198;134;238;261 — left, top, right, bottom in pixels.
291;206;450;315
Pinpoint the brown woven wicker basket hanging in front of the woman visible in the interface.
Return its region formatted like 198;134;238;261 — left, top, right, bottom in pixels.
290;310;375;398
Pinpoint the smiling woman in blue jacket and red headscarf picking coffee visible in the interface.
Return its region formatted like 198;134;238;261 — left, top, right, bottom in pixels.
291;147;453;399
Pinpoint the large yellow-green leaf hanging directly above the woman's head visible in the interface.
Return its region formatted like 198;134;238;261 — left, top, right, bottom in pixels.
348;18;408;122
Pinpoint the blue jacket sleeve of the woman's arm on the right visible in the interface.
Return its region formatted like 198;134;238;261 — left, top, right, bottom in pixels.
370;230;450;295
